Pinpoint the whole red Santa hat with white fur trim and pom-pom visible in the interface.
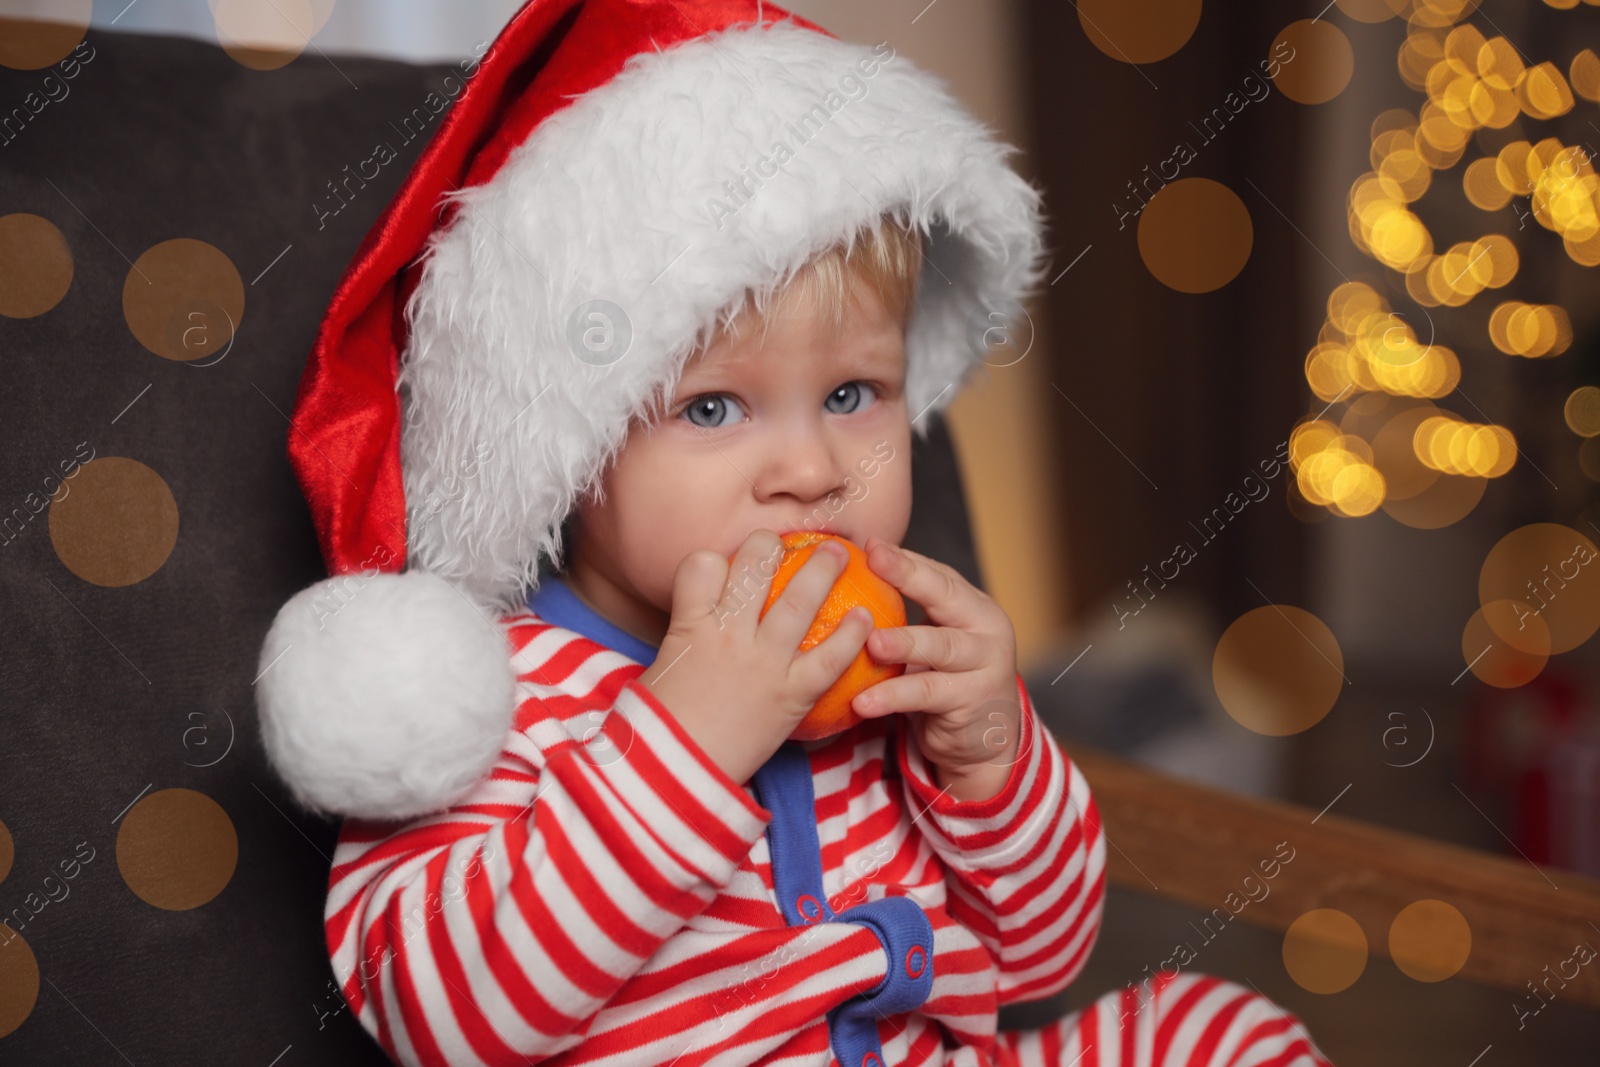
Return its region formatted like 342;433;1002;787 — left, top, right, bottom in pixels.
256;0;1043;819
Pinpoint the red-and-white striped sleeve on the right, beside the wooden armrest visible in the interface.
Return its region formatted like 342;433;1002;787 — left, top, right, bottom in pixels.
894;675;1106;1003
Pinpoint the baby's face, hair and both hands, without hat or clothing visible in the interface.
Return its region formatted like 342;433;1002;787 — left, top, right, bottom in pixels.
556;219;1021;800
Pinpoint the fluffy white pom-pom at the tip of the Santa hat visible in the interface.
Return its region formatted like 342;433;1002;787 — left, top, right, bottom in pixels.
256;571;515;819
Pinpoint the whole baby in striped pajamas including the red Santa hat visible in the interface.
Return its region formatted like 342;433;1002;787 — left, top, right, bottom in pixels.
258;0;1326;1067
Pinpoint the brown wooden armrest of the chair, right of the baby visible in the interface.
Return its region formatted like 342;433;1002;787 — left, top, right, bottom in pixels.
1069;747;1600;1008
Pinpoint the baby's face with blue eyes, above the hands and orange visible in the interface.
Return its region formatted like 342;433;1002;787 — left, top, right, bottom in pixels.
570;285;910;643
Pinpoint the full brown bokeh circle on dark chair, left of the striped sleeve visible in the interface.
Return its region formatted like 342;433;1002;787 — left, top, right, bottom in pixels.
117;789;238;912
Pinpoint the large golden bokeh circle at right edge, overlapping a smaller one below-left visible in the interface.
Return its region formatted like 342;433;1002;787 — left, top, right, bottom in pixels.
1478;523;1600;654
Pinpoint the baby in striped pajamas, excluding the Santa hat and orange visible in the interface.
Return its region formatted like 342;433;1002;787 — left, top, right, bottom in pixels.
315;211;1325;1067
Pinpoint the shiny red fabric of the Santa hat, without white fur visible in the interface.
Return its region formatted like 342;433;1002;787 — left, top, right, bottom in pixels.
290;0;827;585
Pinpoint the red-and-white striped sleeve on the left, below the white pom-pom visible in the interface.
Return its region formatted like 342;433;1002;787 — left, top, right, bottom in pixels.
325;624;771;1067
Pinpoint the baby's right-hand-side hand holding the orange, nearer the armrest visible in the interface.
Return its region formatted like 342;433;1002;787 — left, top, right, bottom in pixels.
851;536;1022;800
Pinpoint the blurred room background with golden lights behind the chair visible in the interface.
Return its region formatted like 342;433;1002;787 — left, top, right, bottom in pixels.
0;0;1600;1064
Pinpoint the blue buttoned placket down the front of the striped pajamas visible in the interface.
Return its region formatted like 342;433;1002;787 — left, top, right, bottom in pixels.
750;741;933;1067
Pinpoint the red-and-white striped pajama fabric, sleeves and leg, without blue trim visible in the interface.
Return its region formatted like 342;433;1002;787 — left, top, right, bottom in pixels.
325;609;1326;1067
